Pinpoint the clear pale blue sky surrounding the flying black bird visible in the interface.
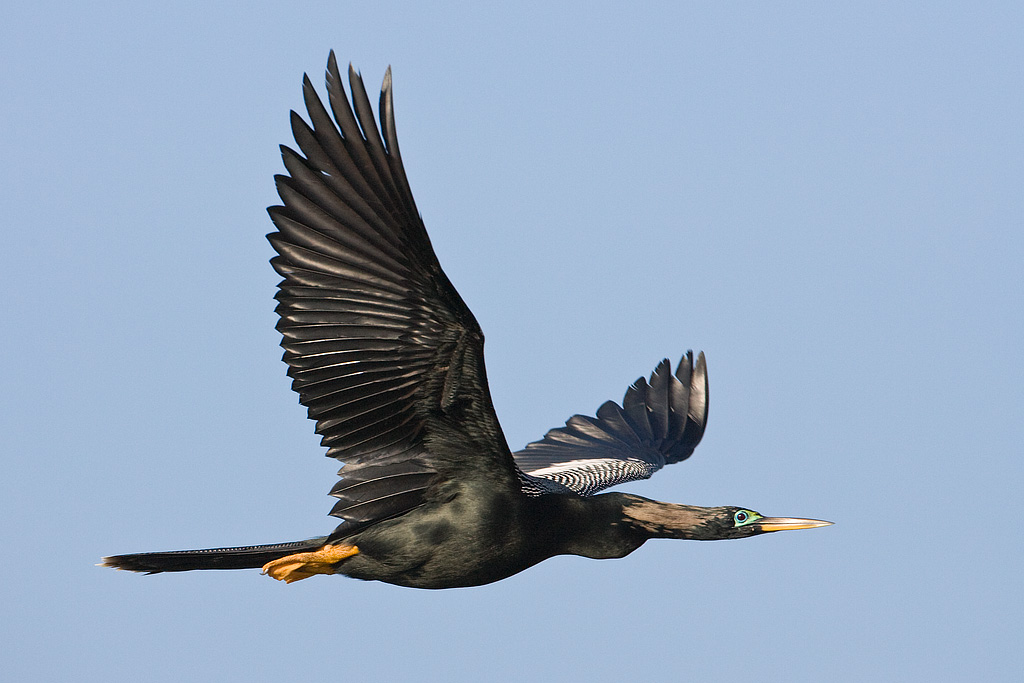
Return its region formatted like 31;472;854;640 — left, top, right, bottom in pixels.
0;0;1024;683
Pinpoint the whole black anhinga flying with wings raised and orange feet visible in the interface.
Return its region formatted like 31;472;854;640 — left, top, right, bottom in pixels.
103;52;830;588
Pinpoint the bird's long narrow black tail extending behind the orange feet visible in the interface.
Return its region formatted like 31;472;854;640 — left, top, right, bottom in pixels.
99;537;327;573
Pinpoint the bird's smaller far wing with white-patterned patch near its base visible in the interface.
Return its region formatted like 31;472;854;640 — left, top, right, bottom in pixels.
513;351;708;496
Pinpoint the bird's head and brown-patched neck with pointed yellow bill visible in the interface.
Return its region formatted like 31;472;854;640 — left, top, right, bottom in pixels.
622;495;831;541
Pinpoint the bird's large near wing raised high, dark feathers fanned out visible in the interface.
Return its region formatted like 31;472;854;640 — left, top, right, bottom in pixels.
267;52;519;536
